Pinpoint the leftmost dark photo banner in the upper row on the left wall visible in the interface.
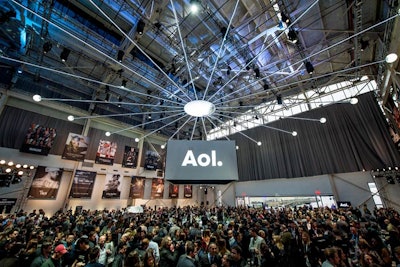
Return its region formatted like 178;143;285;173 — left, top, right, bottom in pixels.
20;123;57;156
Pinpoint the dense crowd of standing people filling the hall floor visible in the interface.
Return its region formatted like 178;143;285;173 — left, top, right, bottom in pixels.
0;203;400;267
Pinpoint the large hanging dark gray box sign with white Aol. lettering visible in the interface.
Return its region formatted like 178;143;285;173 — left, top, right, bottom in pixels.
165;140;238;184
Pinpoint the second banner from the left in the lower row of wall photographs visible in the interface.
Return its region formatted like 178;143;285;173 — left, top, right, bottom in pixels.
69;170;97;198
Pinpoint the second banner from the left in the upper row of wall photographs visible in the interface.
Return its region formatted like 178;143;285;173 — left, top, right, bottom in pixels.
62;133;89;161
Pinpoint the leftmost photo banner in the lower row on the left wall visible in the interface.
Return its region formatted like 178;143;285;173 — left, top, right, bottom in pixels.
28;166;63;199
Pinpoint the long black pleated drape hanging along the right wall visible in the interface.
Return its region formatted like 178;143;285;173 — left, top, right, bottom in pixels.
229;93;400;181
